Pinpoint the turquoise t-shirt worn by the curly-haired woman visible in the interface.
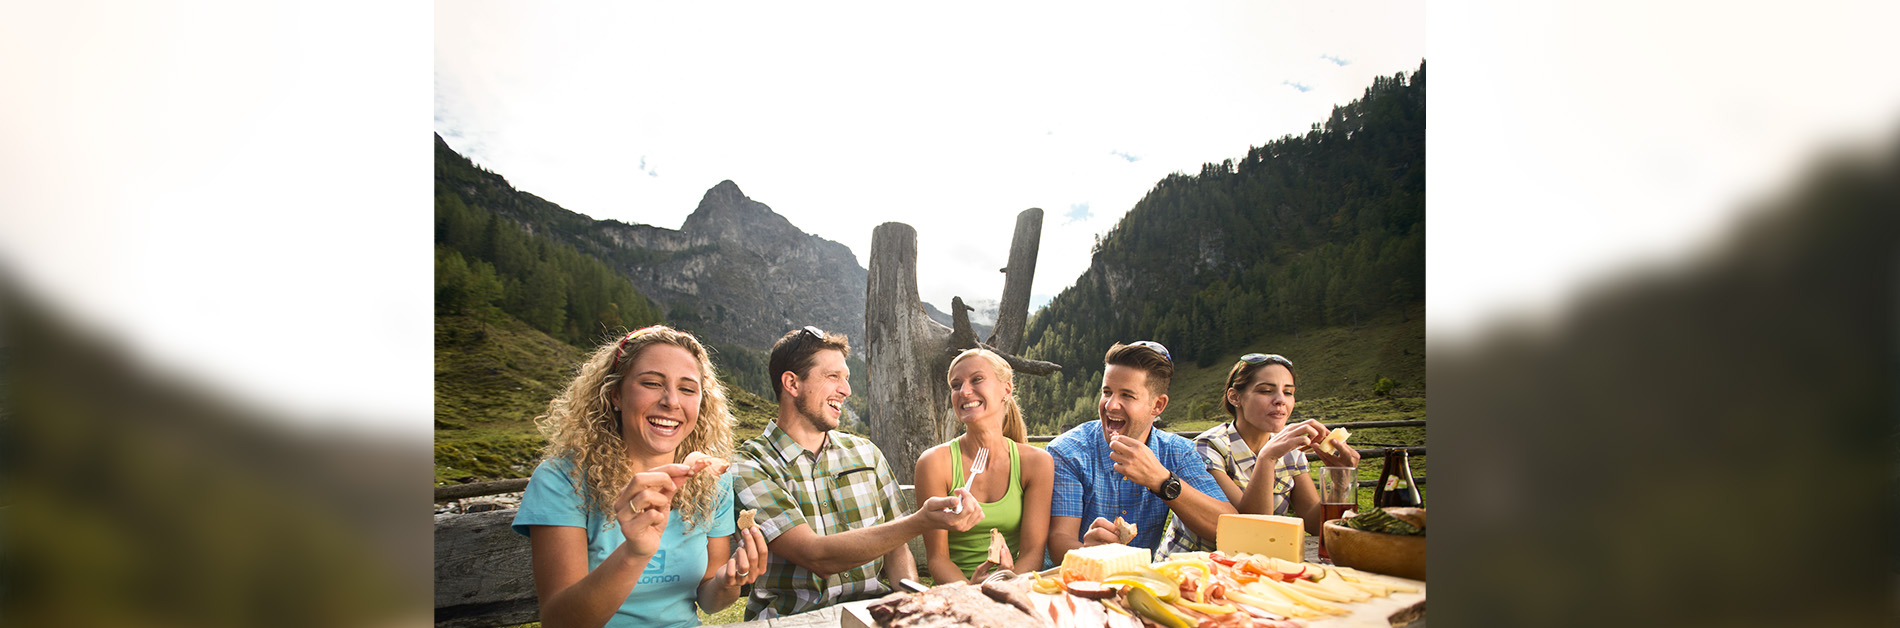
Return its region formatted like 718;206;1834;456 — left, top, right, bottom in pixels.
515;457;733;626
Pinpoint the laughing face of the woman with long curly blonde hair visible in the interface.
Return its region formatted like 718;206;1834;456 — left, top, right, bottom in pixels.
619;343;701;457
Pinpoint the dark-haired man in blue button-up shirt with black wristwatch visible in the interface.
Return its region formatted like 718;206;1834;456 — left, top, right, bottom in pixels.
1049;340;1235;563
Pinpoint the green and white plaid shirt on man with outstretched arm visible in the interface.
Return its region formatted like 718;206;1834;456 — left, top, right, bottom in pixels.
732;421;901;620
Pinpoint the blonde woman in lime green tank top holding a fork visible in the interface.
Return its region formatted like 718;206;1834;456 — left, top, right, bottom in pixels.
916;349;1056;584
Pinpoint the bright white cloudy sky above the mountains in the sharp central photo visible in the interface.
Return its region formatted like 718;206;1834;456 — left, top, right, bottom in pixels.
435;2;1425;309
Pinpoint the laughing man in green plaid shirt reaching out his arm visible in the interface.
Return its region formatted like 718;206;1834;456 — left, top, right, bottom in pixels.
732;326;982;620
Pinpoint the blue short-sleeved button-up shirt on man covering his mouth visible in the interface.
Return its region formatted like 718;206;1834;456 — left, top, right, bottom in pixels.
1049;419;1227;550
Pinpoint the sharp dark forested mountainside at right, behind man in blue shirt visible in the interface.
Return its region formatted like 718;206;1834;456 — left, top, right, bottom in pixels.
1018;63;1425;433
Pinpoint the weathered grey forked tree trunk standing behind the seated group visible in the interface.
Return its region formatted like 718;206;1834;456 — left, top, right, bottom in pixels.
865;218;1062;484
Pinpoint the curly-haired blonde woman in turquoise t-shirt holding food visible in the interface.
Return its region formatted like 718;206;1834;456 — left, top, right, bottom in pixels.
515;324;766;628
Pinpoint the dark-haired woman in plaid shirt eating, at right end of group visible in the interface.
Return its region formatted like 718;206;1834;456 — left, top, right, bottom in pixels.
1163;353;1359;552
